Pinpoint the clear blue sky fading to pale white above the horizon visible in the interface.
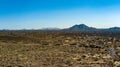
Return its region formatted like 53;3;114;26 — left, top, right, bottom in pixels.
0;0;120;29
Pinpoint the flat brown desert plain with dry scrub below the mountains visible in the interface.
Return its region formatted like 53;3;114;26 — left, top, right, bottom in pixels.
0;31;120;67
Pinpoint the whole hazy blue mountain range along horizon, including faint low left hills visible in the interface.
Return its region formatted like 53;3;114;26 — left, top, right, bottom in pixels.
0;24;120;33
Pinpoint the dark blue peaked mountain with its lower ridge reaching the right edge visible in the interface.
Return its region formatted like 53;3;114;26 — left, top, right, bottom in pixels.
63;24;120;33
